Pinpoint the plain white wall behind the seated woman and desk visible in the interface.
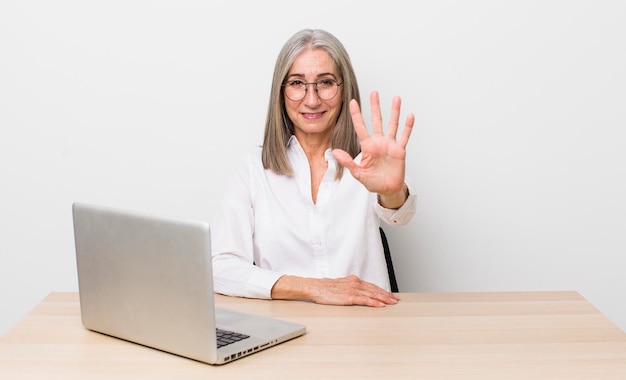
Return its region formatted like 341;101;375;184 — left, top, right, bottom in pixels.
0;0;626;334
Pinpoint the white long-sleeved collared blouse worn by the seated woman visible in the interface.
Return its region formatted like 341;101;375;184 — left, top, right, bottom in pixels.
211;136;417;298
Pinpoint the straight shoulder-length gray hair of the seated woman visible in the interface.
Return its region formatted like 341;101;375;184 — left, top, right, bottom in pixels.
262;29;361;178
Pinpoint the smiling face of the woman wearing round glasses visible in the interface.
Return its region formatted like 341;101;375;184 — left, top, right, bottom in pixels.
284;49;343;143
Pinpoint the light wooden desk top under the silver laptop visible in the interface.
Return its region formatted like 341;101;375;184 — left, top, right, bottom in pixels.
0;292;626;380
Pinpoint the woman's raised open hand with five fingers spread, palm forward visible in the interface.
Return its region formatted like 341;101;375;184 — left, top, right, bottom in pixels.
333;91;415;202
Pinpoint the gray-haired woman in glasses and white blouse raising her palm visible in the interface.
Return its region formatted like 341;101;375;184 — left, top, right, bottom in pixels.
211;29;415;307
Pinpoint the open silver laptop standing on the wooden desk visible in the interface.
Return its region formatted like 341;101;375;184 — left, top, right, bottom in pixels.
72;202;306;364
